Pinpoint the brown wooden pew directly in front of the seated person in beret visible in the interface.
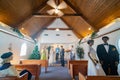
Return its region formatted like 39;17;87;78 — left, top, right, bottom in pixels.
15;64;41;80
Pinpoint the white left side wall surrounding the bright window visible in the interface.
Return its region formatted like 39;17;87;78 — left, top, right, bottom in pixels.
0;23;34;63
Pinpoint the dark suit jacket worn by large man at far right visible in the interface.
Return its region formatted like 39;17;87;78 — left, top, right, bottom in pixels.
97;44;119;65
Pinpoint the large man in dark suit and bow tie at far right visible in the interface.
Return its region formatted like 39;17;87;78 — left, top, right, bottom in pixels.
97;36;119;75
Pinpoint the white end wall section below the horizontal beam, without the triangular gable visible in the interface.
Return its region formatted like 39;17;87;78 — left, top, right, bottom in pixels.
40;30;78;43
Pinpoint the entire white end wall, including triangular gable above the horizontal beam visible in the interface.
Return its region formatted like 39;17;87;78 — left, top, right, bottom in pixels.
39;18;78;44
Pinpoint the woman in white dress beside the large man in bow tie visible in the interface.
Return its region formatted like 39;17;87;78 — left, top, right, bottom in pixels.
87;40;105;76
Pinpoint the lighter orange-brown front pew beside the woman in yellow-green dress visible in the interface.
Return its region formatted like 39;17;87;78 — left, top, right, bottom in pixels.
20;59;48;72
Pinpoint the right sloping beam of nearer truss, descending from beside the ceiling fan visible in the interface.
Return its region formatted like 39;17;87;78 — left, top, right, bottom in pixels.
64;0;98;31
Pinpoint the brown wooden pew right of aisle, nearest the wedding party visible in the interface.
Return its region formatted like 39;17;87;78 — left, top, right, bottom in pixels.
68;60;88;78
